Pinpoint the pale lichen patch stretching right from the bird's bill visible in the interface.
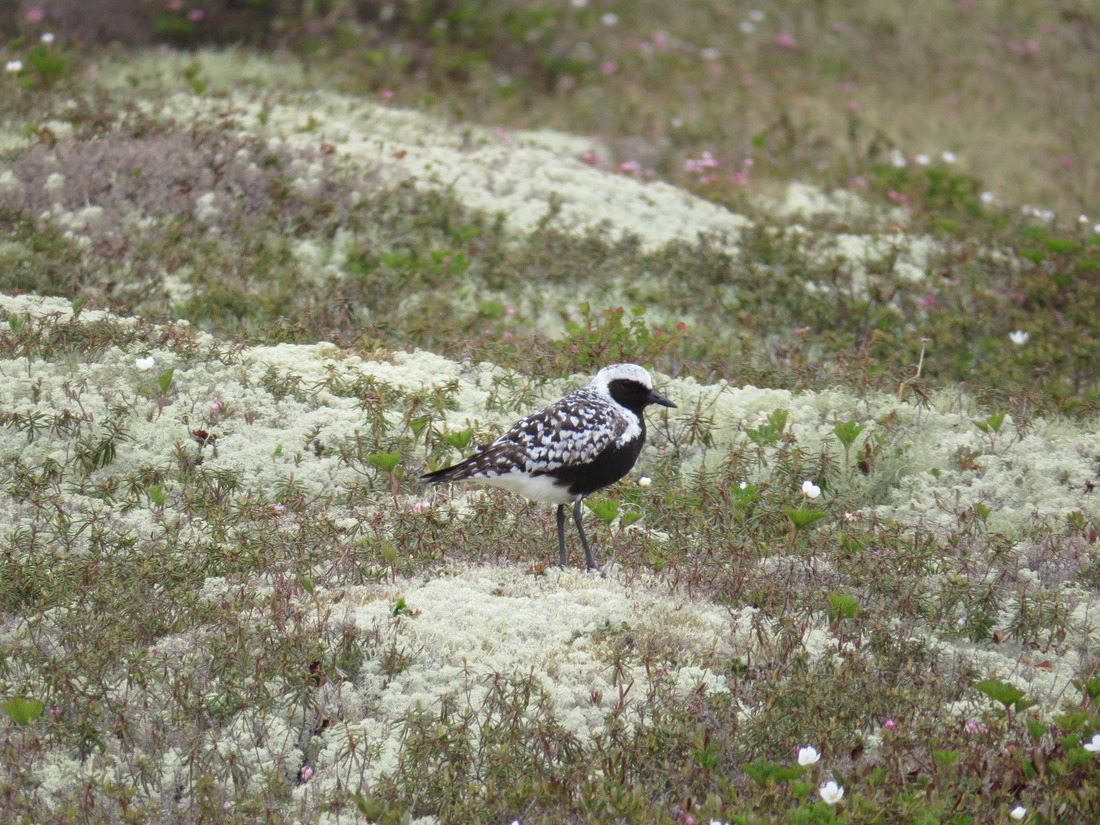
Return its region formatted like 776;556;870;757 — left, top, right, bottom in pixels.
664;371;1100;534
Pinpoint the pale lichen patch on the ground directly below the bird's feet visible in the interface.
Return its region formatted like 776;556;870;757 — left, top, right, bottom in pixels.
297;568;750;778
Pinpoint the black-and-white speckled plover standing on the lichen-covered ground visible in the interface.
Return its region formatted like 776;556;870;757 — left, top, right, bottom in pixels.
419;364;677;570
